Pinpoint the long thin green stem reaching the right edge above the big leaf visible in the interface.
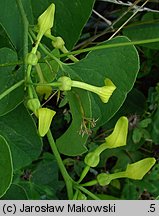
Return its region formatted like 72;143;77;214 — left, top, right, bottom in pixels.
58;38;159;57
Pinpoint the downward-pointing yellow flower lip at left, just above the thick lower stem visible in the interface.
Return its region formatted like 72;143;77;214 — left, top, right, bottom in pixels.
37;108;56;137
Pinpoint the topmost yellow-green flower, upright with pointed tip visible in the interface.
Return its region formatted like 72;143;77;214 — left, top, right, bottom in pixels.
37;3;55;41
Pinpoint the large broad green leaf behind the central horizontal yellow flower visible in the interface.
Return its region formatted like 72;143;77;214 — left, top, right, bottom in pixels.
68;37;139;126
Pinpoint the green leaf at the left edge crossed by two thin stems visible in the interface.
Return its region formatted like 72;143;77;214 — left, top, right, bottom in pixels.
0;48;24;116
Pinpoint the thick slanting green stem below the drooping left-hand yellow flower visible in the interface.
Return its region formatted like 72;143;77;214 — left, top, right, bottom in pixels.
47;130;73;199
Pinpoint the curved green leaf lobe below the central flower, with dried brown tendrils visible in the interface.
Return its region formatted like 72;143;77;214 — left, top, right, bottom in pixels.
56;89;91;156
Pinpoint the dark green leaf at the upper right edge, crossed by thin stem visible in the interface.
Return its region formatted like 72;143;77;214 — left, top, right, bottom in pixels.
123;13;159;49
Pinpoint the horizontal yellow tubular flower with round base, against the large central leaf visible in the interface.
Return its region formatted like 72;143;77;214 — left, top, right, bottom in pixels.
58;76;116;103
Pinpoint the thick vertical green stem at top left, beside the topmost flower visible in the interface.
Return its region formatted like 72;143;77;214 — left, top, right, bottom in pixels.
16;0;28;71
